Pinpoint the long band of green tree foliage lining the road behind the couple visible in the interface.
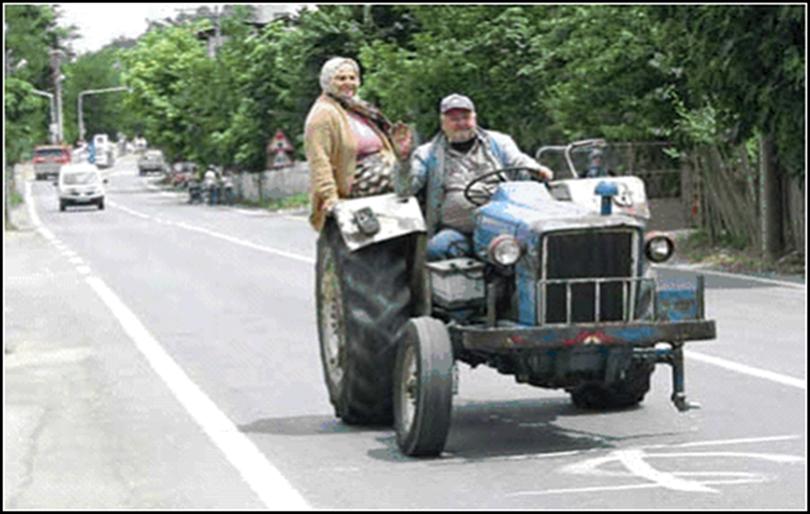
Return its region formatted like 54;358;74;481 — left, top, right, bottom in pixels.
7;4;805;184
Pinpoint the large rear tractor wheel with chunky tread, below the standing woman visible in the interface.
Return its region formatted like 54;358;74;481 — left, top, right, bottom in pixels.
315;219;411;425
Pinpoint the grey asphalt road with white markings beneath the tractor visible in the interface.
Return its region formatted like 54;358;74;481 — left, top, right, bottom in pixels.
3;158;807;510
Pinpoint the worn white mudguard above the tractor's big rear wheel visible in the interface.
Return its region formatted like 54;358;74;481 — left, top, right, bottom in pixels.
333;193;426;252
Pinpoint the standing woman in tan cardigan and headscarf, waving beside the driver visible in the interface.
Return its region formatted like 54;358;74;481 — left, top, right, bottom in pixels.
304;57;411;231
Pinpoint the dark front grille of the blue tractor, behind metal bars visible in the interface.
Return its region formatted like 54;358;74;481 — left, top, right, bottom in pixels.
537;229;639;324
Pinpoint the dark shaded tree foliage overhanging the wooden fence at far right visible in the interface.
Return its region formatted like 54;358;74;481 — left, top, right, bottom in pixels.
649;5;806;177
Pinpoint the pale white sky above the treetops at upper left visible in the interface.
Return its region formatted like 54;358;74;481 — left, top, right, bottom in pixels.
56;3;222;53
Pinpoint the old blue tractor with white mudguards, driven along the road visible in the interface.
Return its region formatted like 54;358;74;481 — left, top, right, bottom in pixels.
316;139;715;456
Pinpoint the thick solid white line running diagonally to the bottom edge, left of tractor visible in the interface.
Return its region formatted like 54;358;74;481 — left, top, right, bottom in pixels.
85;277;310;510
